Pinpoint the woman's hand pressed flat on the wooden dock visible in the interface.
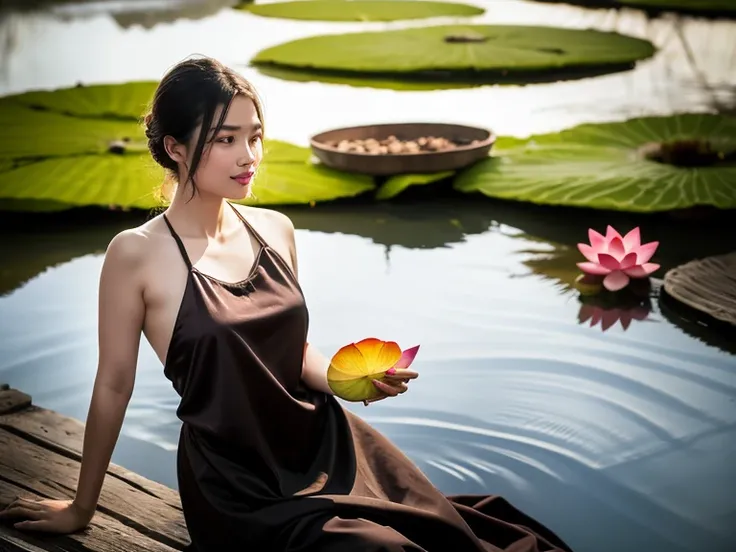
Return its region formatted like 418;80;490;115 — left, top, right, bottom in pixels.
0;497;93;533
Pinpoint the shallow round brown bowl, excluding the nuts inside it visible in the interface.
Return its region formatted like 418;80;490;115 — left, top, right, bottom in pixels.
310;123;496;176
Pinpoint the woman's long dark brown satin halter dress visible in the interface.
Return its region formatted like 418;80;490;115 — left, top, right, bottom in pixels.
164;205;569;552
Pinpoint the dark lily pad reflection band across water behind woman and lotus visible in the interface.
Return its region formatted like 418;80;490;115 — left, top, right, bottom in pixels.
0;198;736;358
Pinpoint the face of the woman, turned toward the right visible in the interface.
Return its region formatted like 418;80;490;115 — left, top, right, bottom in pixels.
187;94;263;199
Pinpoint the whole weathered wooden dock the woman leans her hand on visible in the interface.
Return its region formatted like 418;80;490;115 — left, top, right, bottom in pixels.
0;386;189;552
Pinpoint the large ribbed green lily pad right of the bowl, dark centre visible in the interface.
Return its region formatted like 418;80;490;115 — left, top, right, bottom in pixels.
454;114;736;212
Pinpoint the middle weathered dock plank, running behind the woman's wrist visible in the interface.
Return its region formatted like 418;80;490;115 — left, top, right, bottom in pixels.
0;429;189;549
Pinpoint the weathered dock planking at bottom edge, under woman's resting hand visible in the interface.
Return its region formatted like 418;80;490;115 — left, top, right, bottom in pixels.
0;479;176;552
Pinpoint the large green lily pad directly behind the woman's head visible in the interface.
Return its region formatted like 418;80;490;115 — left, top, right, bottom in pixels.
0;82;374;211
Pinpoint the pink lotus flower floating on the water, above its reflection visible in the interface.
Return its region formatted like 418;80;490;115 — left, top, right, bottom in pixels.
578;226;659;291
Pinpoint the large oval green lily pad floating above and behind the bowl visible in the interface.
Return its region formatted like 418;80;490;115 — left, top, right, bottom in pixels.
251;25;655;86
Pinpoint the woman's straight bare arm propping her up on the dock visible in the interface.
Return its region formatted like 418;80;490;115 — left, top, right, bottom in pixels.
74;231;145;519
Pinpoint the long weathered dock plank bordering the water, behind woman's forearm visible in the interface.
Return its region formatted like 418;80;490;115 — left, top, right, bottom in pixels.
0;406;181;510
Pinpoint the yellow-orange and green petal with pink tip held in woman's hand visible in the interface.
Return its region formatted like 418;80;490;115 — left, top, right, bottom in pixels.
327;337;419;402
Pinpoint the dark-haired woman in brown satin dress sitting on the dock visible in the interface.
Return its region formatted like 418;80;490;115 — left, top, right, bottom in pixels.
2;58;569;552
